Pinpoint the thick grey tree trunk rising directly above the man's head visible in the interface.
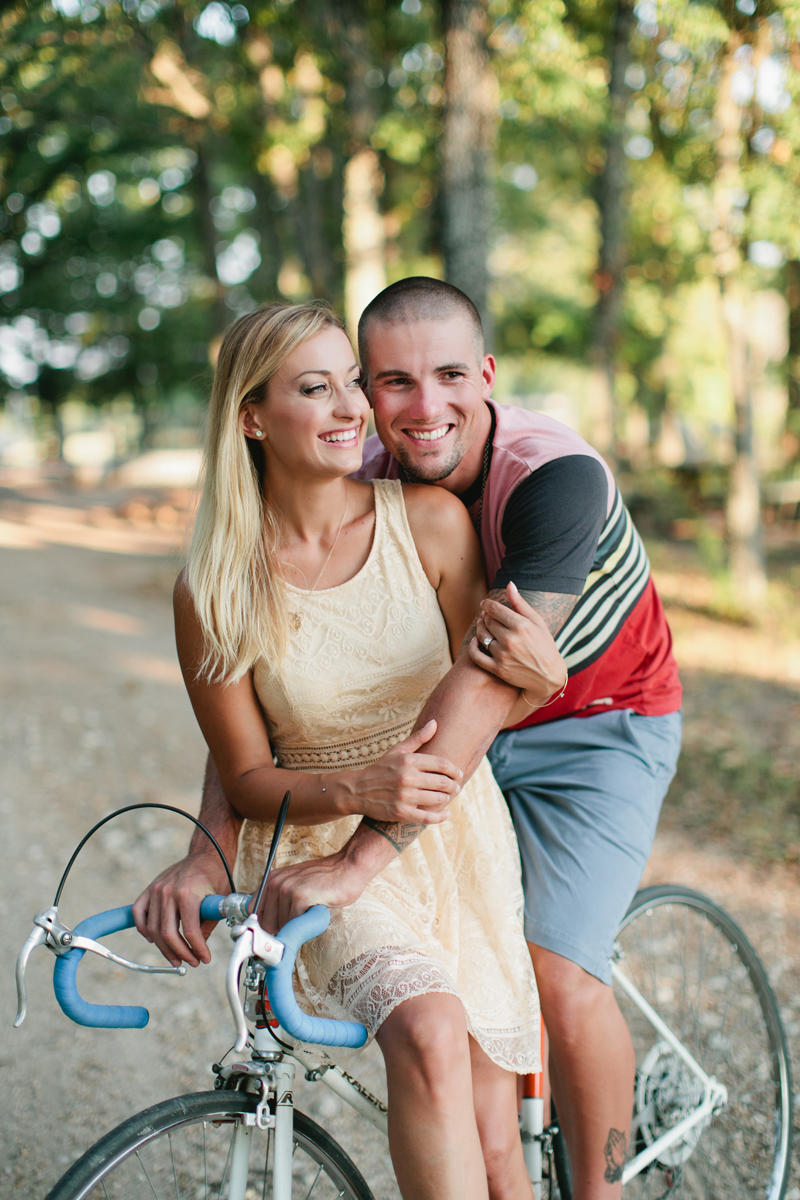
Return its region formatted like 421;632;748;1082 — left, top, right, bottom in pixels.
439;0;497;340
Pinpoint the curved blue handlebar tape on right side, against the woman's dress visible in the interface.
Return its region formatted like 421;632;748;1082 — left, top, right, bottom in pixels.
266;904;367;1049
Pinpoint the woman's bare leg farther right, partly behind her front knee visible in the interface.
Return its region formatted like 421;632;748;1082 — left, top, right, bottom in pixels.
469;1038;534;1200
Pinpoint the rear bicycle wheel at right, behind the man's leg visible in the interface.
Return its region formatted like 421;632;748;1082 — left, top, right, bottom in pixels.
615;884;792;1200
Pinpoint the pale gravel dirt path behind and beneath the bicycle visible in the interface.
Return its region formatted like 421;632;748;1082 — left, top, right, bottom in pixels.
0;482;800;1200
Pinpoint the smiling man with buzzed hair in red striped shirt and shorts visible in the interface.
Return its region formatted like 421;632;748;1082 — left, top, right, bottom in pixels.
137;278;681;1200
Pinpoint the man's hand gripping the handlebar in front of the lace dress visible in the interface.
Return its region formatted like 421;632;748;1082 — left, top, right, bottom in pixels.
258;846;374;934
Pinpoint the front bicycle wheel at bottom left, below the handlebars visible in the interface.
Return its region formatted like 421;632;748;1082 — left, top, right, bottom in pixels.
47;1091;373;1200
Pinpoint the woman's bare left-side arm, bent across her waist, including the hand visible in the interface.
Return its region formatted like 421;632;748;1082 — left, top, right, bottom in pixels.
174;576;458;826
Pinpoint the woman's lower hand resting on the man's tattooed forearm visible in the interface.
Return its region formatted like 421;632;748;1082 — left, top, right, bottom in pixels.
339;721;463;824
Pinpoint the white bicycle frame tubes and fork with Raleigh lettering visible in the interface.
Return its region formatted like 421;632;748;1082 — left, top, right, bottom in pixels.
228;945;728;1200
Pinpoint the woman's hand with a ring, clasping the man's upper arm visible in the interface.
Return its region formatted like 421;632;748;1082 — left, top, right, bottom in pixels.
469;583;577;707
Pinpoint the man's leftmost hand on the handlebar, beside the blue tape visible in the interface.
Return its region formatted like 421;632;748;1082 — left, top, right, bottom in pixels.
133;851;230;967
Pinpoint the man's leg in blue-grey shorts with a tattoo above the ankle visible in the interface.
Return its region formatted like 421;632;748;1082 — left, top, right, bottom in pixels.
489;712;680;1200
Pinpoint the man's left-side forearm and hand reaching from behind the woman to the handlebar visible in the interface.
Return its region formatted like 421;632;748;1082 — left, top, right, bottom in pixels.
133;755;242;967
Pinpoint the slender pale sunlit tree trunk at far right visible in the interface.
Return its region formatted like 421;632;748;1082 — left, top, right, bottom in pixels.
711;31;766;606
